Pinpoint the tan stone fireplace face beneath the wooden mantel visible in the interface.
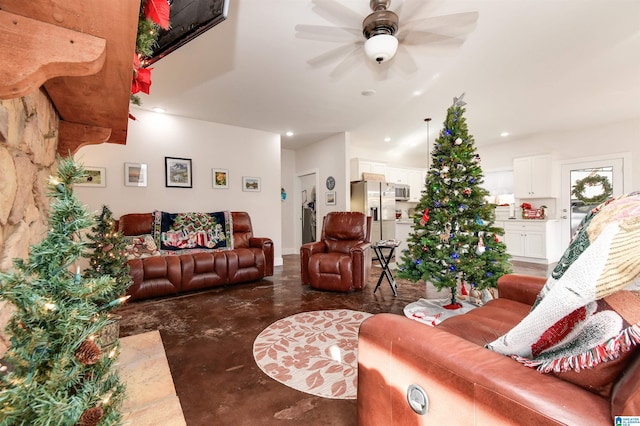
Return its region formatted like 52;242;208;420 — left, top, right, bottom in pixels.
0;89;59;356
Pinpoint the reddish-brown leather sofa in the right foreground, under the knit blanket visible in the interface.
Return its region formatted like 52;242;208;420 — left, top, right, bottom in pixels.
358;274;640;426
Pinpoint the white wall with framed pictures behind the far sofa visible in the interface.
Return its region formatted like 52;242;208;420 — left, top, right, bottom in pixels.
75;109;283;265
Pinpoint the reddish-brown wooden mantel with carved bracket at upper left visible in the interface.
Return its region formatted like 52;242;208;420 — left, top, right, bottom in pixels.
0;0;140;155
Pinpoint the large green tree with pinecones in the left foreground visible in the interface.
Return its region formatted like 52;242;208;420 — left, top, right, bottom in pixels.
0;159;124;426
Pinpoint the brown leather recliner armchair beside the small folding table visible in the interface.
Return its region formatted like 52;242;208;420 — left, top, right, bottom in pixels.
300;212;372;292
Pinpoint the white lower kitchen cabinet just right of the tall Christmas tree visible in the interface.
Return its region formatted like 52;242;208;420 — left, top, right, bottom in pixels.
502;220;561;264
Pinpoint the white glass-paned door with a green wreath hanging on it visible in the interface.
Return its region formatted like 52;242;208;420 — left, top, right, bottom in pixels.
560;156;630;252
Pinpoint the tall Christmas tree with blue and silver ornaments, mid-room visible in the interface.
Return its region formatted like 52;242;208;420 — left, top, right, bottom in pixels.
398;94;510;308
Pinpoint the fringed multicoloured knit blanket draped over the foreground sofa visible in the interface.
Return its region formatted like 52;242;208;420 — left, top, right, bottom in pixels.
487;192;640;373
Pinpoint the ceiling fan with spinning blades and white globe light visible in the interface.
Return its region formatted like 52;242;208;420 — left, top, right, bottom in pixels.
295;0;478;77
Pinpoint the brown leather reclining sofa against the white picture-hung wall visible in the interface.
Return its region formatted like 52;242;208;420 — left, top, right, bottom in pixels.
117;212;273;300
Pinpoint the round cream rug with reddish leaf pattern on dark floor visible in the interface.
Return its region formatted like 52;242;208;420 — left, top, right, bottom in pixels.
253;309;372;399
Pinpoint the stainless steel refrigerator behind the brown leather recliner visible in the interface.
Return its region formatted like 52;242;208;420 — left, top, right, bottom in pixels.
351;180;396;243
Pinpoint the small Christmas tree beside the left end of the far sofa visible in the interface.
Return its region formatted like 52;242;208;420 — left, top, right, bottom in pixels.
83;206;132;303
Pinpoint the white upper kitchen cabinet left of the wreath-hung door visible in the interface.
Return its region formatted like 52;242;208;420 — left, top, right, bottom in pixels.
513;155;555;199
